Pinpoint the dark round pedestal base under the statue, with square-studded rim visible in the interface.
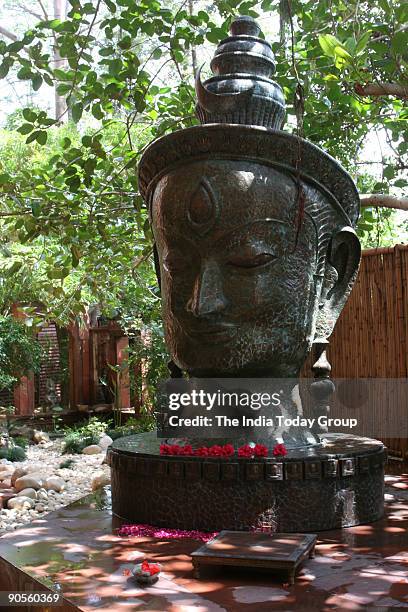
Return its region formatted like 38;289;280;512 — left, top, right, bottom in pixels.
108;432;386;532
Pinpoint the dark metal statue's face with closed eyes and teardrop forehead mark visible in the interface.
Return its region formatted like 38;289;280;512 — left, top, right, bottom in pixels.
152;160;320;377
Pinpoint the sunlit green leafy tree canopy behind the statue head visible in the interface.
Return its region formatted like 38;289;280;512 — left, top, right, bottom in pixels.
0;0;408;321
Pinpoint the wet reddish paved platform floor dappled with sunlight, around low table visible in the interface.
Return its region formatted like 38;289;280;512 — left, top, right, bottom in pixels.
0;464;408;612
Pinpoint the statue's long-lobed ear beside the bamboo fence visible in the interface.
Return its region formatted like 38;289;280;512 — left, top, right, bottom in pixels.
316;227;361;338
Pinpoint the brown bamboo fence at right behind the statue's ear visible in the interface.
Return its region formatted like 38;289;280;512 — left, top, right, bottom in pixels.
327;245;408;458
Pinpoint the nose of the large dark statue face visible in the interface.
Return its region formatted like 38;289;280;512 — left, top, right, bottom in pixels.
187;262;227;317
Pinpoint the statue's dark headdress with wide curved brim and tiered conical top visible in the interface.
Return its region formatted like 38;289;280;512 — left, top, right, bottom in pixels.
139;17;360;226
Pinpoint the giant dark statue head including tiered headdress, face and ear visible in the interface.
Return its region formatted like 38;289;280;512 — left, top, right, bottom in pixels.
139;17;360;377
